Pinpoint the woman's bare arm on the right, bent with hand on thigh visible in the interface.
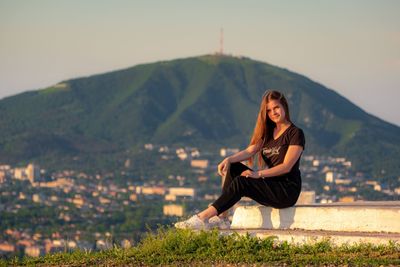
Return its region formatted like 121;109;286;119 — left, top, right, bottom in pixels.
241;145;303;178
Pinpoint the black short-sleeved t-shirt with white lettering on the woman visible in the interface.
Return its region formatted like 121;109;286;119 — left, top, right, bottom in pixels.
262;123;305;178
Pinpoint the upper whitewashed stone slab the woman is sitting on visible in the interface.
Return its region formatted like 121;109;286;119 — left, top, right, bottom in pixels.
231;201;400;234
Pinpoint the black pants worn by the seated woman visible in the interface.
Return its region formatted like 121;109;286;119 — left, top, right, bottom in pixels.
212;162;301;215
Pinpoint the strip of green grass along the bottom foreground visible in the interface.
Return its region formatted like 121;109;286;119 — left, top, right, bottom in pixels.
0;228;400;266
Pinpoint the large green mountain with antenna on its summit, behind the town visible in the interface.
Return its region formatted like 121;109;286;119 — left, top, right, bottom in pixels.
0;55;400;176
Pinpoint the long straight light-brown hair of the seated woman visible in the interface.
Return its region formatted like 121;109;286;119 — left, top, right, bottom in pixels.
249;90;291;169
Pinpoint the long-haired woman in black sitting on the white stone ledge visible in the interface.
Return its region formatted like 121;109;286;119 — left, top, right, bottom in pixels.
175;91;305;229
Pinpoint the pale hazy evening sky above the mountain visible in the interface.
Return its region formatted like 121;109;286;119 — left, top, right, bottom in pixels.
0;0;400;126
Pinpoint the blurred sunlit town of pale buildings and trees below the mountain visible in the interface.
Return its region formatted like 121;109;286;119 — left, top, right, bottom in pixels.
0;144;400;257
